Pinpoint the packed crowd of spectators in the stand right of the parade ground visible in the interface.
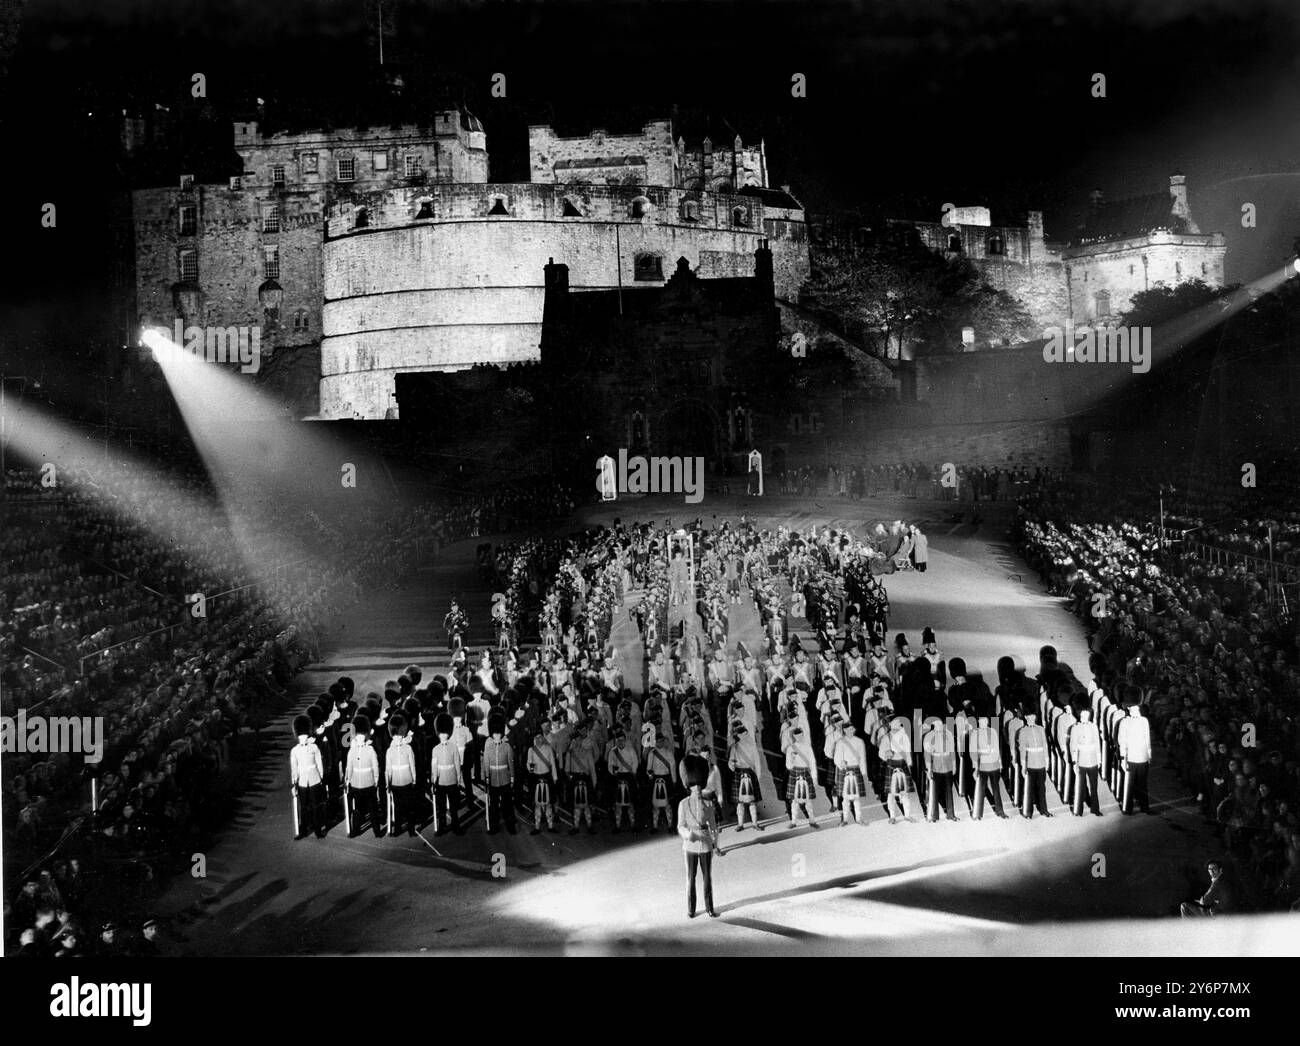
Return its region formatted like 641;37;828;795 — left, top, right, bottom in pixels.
1013;483;1300;910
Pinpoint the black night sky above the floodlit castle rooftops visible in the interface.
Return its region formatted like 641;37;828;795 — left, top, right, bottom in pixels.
0;0;1300;384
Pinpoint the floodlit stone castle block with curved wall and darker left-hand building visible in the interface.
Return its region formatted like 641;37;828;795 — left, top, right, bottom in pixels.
133;110;809;420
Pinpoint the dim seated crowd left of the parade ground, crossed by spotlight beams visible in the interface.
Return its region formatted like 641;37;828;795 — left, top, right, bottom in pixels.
0;464;572;955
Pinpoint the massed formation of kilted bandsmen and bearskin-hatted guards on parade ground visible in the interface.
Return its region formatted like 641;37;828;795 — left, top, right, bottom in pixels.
291;520;1151;862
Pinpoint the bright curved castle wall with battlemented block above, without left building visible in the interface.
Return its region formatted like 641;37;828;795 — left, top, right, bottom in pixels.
320;121;809;418
